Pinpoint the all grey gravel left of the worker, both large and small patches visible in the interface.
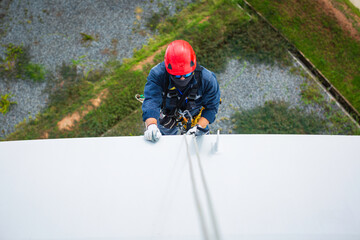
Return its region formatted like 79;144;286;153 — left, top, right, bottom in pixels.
0;0;191;139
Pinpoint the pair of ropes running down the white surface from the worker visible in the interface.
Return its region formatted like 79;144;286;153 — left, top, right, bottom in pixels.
184;135;220;240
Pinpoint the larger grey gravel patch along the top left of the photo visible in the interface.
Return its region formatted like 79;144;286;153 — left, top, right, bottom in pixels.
0;0;186;71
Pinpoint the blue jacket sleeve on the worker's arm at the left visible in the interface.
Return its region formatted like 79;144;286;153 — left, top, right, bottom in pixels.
142;66;163;121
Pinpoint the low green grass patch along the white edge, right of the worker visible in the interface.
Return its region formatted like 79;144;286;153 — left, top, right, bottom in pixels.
231;101;360;135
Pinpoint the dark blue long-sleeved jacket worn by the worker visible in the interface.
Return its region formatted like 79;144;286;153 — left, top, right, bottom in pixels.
142;62;220;123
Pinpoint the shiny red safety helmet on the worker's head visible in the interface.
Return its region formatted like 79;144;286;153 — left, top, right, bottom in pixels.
165;40;196;75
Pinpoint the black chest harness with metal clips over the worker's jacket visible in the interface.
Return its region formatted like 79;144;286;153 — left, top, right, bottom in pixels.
160;65;204;133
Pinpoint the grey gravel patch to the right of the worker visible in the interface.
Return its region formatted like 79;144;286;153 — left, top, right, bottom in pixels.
210;59;348;133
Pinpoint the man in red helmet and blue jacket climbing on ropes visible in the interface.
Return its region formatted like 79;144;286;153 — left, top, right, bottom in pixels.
142;40;220;142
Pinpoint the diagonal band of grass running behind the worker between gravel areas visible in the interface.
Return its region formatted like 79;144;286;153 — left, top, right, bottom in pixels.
6;0;360;140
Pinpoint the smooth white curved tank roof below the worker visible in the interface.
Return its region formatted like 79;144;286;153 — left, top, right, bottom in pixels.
0;135;360;240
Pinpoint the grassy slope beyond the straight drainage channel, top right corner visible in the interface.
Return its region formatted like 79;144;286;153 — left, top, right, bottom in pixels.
240;0;360;117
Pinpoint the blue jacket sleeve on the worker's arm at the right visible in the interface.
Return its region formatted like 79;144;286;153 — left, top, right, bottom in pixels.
201;71;220;123
